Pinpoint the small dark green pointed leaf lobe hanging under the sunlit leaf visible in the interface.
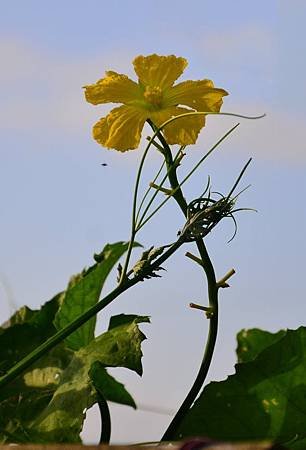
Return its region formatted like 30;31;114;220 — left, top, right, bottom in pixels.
89;361;136;409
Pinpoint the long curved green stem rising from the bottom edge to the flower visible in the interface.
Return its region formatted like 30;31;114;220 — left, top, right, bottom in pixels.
146;122;218;441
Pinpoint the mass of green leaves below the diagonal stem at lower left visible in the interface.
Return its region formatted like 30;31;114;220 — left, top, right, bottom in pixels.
0;308;149;443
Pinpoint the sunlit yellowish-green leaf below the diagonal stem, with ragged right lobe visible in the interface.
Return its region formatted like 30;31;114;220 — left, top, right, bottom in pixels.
27;316;149;443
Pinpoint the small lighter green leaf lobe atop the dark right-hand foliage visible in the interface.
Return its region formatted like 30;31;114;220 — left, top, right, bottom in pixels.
236;328;286;362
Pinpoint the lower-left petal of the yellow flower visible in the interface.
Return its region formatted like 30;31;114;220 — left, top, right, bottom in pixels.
93;105;147;152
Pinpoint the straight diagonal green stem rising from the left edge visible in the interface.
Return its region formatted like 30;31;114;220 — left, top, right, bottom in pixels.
0;237;184;388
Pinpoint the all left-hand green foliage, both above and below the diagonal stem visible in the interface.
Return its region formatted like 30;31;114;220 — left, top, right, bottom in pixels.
0;242;149;444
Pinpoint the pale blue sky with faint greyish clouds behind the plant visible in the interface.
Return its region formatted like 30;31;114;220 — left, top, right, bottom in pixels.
0;0;306;443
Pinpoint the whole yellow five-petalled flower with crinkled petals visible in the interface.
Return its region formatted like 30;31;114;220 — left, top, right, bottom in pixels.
85;54;227;152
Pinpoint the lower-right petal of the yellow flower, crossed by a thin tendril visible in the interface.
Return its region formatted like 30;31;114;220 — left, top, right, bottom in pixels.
150;107;205;145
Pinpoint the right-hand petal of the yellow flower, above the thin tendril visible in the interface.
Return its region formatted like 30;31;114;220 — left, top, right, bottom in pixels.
164;80;228;112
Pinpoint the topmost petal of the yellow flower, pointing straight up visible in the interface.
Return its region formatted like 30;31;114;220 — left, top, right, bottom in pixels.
133;54;188;89
